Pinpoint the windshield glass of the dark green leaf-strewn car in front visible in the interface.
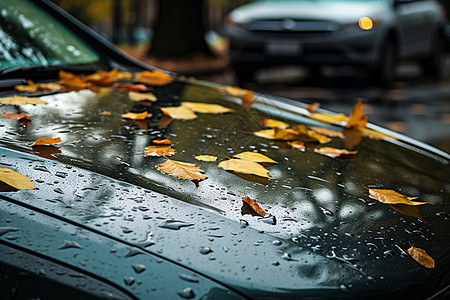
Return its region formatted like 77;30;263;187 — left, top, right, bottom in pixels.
0;0;99;70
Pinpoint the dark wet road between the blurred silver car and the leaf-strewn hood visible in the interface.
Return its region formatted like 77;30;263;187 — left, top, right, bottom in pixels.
199;55;450;153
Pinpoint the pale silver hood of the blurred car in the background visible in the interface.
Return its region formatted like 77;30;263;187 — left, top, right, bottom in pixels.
230;1;389;24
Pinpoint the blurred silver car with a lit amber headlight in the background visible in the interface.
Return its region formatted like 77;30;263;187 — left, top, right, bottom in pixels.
225;0;445;85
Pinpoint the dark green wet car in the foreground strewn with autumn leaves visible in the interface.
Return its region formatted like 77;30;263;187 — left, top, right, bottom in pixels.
0;0;450;299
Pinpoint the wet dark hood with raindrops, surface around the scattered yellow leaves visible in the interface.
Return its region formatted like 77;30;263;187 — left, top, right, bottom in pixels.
0;78;450;298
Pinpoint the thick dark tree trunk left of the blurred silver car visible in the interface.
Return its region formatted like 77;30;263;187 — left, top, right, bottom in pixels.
148;0;212;58
